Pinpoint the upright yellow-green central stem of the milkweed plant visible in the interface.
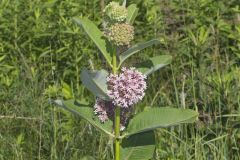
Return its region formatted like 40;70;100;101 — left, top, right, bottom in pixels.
112;48;120;160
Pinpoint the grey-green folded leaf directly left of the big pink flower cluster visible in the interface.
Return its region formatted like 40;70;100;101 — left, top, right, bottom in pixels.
80;68;109;100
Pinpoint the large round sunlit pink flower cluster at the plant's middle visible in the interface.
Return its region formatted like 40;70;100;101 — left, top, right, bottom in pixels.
107;67;147;108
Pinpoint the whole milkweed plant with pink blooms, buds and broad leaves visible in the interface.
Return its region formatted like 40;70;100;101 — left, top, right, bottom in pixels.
54;1;198;160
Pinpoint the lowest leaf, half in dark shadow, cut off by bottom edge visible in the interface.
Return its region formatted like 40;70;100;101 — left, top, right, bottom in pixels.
120;131;155;160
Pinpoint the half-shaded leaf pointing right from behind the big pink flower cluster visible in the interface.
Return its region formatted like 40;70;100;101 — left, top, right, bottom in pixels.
136;55;172;76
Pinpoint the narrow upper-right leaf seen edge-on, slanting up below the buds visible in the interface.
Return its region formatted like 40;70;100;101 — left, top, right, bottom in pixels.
119;39;160;66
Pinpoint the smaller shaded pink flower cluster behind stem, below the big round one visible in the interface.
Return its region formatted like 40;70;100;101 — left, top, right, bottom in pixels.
94;98;130;131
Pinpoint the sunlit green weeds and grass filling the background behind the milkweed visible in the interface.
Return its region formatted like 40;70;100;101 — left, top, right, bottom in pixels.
0;0;240;160
